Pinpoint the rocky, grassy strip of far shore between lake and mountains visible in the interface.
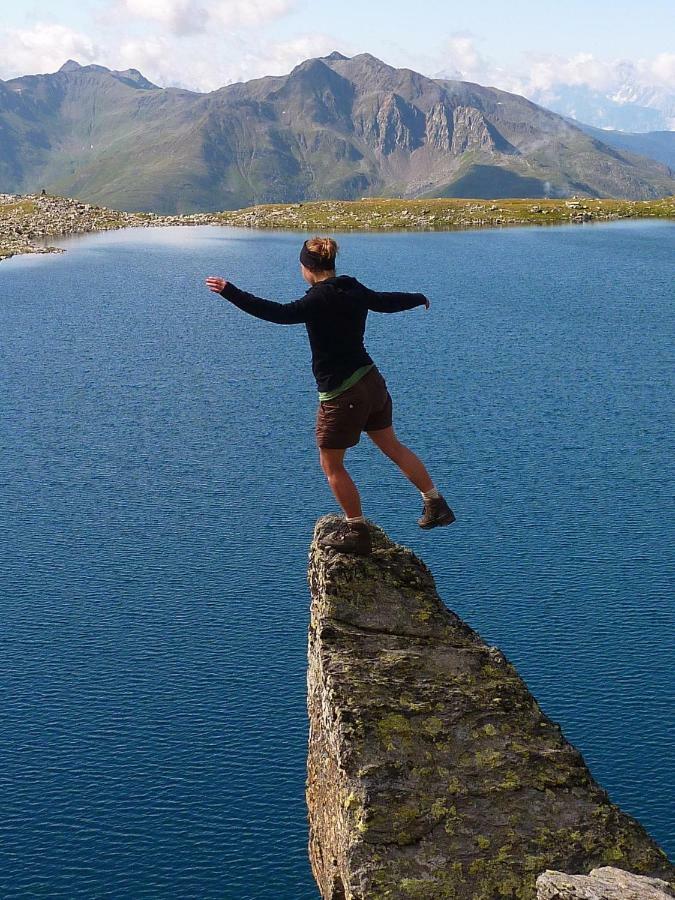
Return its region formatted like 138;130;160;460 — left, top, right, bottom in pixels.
0;194;675;259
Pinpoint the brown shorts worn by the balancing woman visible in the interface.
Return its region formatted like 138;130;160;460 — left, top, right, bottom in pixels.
316;366;392;450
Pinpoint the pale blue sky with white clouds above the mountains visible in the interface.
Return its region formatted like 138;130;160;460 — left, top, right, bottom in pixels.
0;0;675;97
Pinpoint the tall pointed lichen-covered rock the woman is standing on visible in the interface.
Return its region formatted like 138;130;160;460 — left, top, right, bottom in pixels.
307;516;675;900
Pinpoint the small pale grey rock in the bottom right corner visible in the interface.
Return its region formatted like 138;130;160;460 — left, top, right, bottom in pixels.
537;866;675;900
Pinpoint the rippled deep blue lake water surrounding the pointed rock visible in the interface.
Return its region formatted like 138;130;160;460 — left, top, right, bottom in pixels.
0;222;675;900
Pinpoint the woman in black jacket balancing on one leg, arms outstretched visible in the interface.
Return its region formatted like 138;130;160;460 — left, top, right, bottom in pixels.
206;237;455;555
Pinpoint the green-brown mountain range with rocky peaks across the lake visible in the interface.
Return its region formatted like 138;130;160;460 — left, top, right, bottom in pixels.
0;52;675;213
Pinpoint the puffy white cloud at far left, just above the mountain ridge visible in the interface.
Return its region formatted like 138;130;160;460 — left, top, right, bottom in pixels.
0;22;101;80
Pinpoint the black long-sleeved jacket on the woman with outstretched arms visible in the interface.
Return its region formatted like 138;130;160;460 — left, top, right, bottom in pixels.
221;275;427;391
